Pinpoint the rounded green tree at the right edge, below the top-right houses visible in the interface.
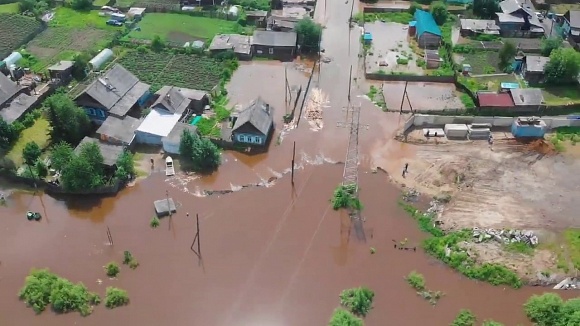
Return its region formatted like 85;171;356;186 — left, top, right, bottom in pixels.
544;48;580;85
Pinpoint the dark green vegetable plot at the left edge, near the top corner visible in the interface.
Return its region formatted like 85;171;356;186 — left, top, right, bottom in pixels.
0;13;40;57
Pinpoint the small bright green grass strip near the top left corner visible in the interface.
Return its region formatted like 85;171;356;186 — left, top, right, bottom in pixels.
49;7;119;30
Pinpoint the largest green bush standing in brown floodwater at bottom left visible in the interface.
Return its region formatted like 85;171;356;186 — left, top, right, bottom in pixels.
18;269;101;316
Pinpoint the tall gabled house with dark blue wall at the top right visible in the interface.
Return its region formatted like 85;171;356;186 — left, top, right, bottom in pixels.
496;0;544;37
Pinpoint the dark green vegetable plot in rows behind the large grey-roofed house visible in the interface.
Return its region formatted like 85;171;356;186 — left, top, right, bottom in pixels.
119;51;224;91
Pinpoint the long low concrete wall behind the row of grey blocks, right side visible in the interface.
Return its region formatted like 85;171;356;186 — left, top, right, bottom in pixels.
404;114;580;131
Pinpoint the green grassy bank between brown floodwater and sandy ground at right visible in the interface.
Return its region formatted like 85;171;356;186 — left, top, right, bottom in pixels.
399;201;523;289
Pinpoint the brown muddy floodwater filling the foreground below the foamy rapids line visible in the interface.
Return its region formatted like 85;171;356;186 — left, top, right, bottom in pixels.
0;165;567;326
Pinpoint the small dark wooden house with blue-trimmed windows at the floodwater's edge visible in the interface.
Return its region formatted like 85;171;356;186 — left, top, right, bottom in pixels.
232;97;274;146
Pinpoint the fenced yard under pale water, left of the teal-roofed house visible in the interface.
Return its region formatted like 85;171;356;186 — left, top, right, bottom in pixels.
365;22;424;75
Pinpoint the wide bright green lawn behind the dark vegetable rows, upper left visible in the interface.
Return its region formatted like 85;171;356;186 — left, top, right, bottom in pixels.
129;13;239;41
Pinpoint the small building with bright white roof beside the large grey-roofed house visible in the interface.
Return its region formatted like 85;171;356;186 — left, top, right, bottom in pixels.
135;109;181;146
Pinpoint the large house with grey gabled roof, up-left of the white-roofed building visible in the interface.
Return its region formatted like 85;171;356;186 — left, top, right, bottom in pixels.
75;64;151;124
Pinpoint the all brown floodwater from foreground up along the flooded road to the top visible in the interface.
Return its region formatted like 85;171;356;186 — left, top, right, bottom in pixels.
0;2;574;326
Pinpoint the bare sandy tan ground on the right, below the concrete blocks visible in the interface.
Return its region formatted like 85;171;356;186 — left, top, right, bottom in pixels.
377;130;580;279
